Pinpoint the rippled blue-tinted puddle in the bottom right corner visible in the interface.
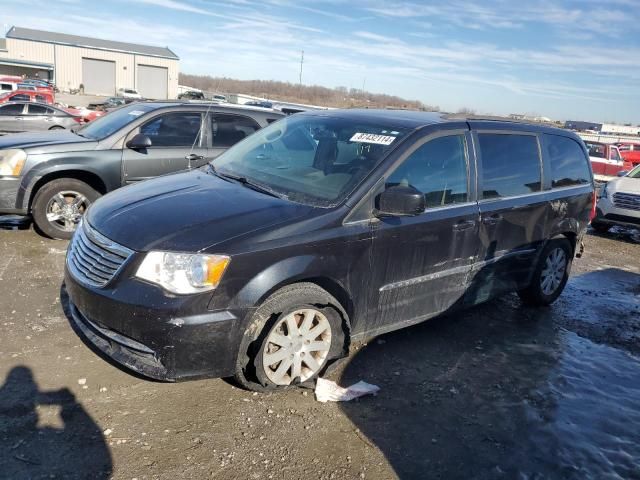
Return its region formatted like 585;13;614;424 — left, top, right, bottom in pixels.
514;331;640;479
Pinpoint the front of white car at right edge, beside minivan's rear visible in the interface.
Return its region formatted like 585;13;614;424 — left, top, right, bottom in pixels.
591;165;640;232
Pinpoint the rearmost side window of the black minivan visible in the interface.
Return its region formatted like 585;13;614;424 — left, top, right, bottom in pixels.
545;135;590;188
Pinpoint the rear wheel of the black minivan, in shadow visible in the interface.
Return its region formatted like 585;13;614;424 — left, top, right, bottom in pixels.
518;238;573;306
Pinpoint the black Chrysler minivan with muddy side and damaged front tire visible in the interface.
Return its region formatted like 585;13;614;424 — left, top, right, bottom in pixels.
65;110;595;390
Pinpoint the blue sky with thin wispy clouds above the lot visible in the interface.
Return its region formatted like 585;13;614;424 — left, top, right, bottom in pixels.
0;0;640;124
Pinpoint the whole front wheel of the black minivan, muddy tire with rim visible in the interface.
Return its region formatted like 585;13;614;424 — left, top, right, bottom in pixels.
235;283;348;392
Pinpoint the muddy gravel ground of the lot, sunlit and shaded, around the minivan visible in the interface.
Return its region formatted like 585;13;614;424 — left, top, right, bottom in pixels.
0;226;640;479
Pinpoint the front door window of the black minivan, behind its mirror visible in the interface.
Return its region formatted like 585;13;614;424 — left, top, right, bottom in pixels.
386;135;468;208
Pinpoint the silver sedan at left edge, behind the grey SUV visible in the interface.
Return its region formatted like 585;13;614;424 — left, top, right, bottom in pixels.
0;102;82;134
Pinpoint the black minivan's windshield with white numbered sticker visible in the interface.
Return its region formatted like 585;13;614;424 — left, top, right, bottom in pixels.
212;114;409;207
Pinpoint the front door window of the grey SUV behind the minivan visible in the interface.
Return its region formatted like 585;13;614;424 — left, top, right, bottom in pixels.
140;112;202;147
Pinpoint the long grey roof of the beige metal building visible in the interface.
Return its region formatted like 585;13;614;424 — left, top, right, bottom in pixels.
7;27;179;60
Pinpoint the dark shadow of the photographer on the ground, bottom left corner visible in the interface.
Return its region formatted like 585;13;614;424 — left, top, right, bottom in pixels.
0;366;112;479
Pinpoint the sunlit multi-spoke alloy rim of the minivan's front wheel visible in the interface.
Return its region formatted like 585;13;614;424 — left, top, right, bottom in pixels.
262;308;331;385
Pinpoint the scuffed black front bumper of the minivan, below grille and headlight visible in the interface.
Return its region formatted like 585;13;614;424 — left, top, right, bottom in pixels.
65;268;247;381
